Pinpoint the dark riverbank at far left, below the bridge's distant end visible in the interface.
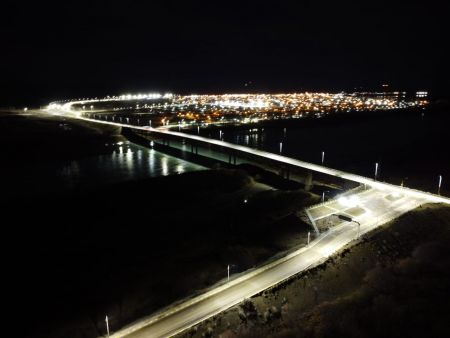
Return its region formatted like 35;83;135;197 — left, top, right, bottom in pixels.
0;111;125;161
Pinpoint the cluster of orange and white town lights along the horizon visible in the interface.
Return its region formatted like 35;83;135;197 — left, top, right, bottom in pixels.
48;92;428;126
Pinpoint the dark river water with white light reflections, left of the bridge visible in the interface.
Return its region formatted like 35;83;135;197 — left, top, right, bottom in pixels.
0;142;202;199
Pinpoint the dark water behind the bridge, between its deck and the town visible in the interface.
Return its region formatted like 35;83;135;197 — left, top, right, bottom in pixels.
194;110;450;191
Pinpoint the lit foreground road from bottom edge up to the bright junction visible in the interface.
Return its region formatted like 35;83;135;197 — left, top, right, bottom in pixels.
111;189;427;338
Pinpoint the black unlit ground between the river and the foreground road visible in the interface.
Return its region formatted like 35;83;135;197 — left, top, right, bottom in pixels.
3;170;312;337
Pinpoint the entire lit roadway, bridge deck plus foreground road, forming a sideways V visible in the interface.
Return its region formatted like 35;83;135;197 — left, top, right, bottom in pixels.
40;104;450;338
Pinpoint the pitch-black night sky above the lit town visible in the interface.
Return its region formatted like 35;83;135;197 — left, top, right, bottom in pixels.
0;0;450;106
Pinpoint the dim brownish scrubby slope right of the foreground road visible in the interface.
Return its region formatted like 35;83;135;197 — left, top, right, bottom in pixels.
179;205;450;338
